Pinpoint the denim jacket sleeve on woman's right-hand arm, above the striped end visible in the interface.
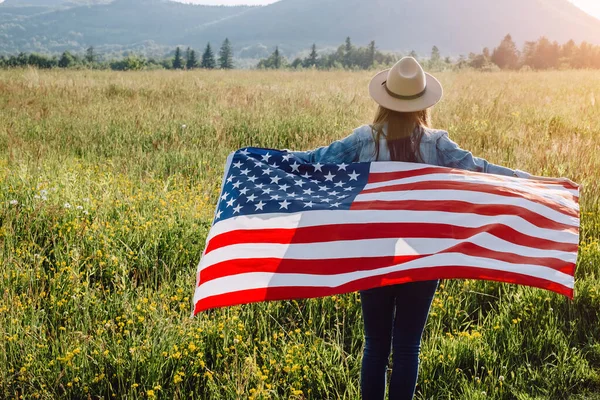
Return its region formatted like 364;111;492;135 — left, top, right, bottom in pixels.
436;132;531;178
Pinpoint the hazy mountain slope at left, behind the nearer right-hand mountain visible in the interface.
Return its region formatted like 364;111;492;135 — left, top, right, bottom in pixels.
0;0;251;54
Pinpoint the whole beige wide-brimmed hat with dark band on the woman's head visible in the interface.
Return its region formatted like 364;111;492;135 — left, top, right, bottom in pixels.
369;57;444;112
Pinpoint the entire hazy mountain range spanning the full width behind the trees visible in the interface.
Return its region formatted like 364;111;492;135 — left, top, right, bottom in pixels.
0;0;600;57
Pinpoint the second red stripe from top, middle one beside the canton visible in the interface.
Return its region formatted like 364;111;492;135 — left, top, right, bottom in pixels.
360;181;579;218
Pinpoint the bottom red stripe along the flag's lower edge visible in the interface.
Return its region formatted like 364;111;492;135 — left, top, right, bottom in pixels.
194;266;573;314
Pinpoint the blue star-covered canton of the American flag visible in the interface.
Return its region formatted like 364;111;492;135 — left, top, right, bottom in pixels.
213;147;370;223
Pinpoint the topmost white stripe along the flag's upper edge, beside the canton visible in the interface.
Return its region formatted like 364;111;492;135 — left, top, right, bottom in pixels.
369;161;579;197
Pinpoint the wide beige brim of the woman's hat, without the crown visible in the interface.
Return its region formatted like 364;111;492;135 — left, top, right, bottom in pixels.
369;69;444;112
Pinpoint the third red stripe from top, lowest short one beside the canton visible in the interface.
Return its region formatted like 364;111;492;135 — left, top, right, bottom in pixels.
350;200;573;230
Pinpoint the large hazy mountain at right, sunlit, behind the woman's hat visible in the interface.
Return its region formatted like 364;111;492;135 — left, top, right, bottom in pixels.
183;0;600;54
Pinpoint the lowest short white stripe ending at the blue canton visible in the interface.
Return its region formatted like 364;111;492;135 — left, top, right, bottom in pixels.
354;189;578;225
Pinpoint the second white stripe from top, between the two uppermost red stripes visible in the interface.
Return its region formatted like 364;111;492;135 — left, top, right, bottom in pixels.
363;170;579;206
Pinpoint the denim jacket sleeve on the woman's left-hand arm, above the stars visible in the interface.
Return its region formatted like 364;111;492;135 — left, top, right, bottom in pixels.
290;131;362;164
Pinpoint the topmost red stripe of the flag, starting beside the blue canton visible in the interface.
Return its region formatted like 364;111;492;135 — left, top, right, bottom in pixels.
367;167;579;194
